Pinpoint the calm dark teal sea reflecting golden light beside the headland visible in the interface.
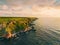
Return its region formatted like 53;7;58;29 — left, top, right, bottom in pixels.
0;17;60;45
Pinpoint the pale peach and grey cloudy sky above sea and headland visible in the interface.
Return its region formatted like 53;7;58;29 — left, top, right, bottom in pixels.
0;0;60;17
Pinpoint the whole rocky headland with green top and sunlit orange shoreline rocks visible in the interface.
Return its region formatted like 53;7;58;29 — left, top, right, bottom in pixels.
0;17;37;39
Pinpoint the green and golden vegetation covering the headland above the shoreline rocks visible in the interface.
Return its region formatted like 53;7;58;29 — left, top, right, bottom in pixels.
0;17;37;36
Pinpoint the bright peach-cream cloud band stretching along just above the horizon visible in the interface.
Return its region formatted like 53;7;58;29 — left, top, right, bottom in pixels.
0;5;60;17
